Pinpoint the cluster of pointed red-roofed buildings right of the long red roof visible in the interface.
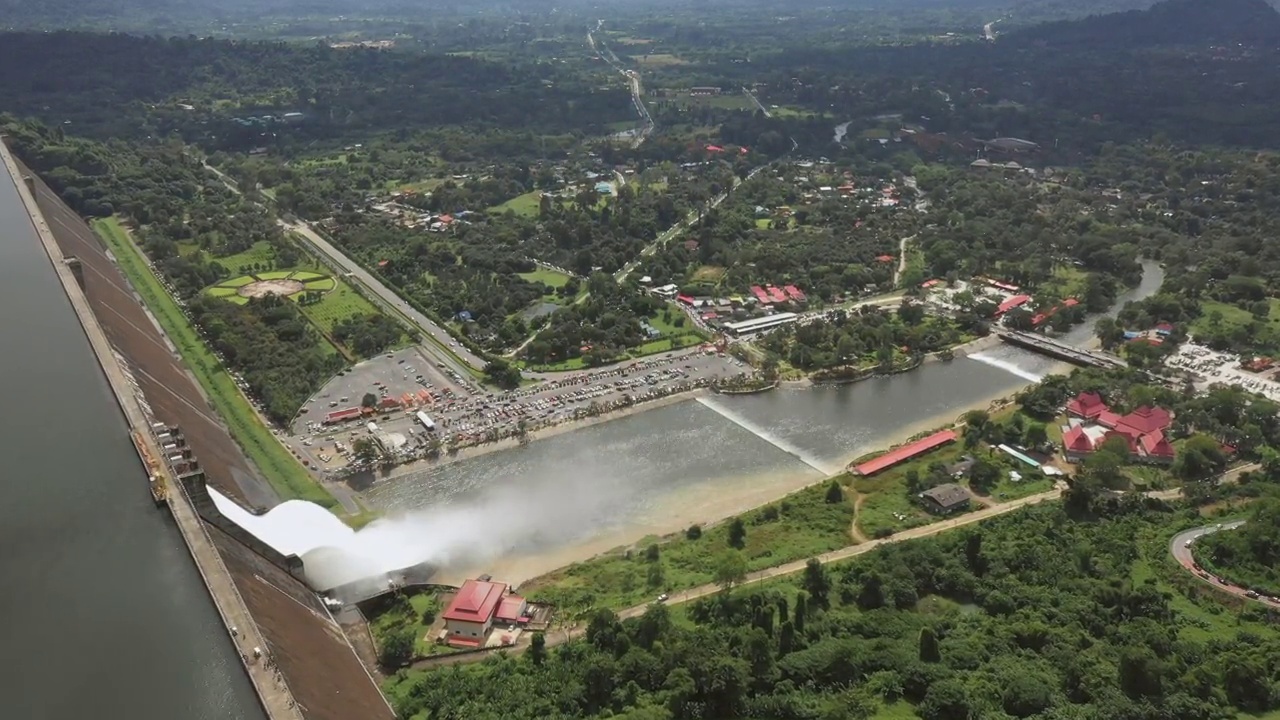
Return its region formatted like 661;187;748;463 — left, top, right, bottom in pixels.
1062;392;1174;464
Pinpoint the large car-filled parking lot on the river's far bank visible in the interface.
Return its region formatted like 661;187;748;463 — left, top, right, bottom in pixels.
285;348;750;475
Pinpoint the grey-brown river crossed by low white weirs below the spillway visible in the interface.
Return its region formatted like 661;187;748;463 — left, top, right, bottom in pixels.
367;263;1164;580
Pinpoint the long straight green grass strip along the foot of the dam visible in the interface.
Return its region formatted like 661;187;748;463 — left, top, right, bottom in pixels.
93;218;338;509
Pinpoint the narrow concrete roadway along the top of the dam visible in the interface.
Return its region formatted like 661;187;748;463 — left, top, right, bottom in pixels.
0;138;302;720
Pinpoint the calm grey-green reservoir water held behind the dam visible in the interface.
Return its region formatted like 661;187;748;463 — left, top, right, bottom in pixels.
0;166;265;720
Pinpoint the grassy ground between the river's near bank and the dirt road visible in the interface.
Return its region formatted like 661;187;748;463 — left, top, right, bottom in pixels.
521;475;854;612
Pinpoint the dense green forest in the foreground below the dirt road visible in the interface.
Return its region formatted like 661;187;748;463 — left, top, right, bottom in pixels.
388;501;1280;720
